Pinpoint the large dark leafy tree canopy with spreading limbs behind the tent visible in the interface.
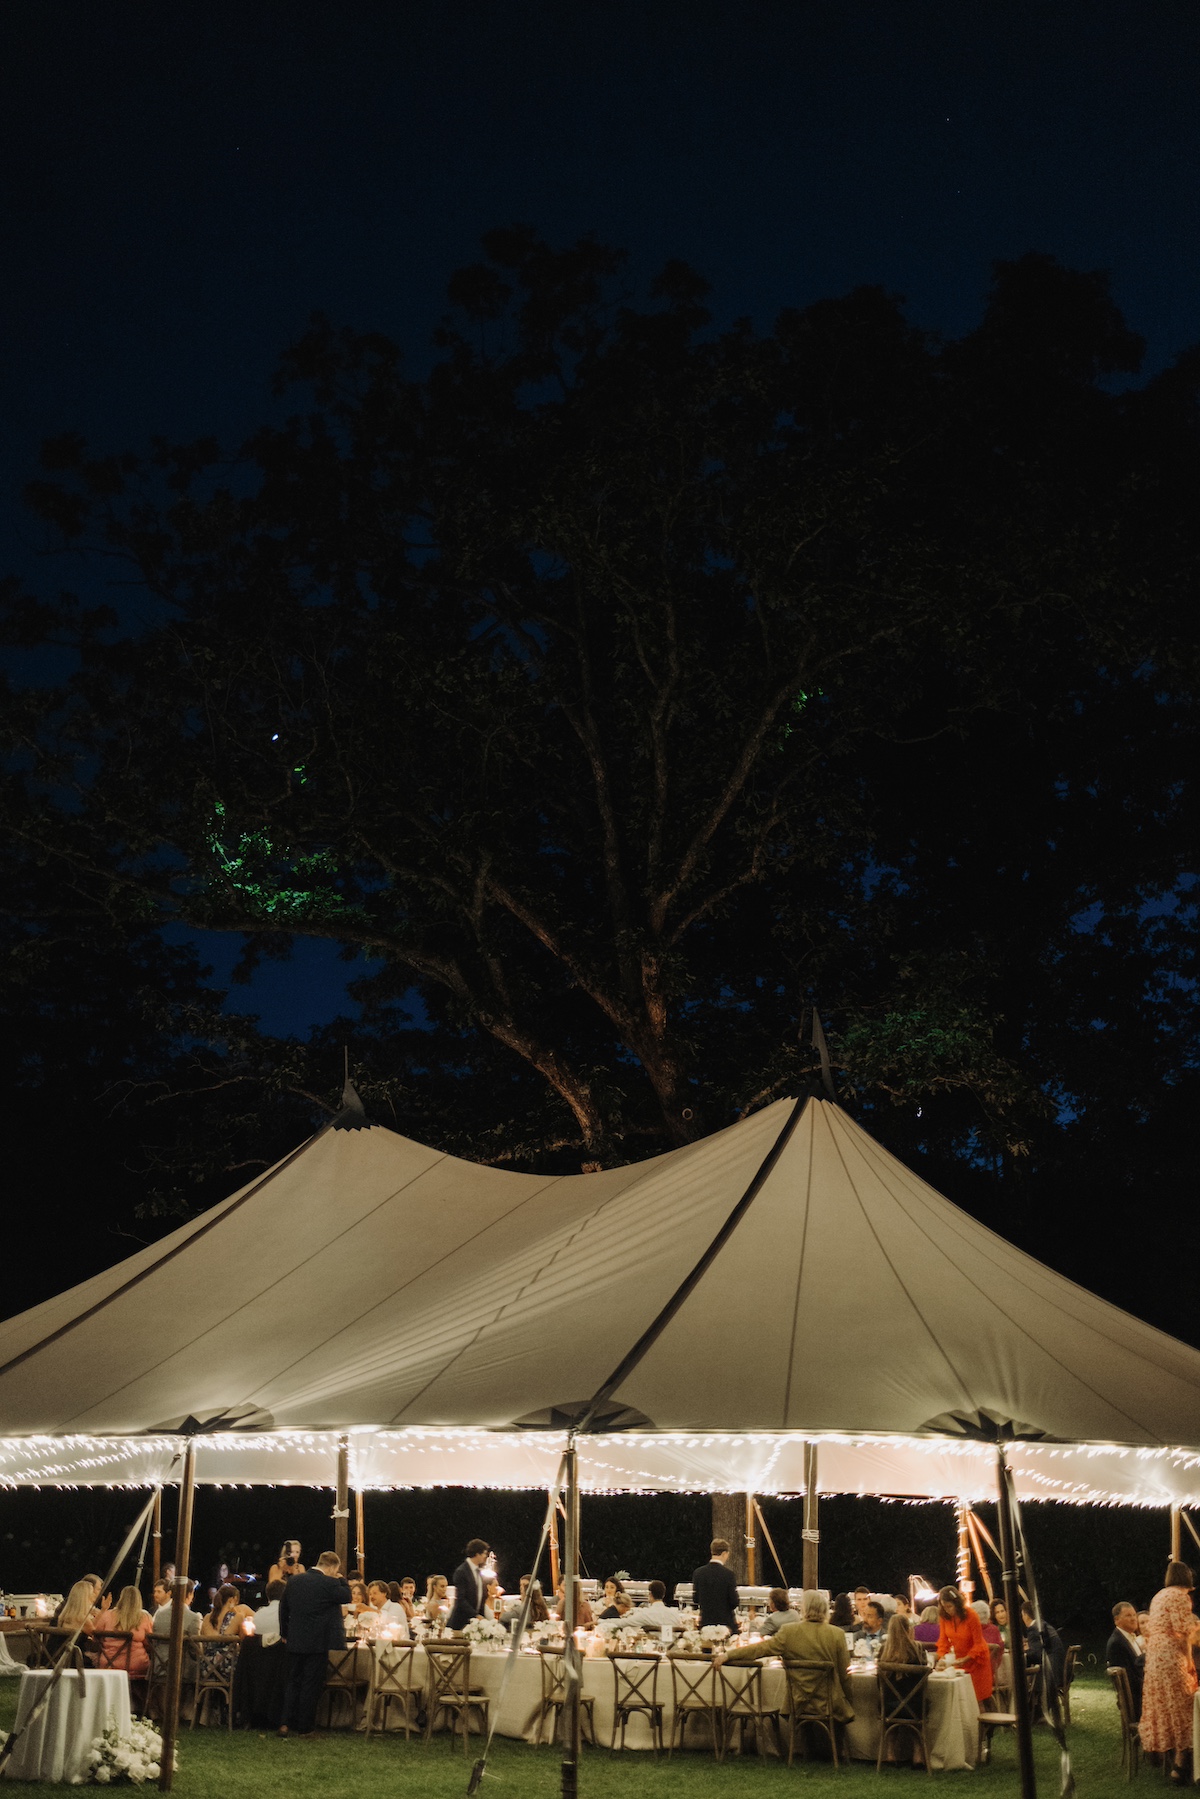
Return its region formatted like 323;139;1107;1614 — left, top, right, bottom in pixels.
4;228;1200;1309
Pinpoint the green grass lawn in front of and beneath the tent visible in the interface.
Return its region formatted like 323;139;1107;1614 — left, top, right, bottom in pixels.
0;1673;1137;1799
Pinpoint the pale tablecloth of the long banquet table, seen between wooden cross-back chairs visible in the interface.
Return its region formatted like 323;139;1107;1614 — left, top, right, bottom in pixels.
356;1648;979;1772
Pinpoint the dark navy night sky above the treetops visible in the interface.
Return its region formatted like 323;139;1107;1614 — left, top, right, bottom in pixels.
0;0;1200;1027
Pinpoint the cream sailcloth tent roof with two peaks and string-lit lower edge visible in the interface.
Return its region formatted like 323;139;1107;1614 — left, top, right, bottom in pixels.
0;1099;1200;1506
